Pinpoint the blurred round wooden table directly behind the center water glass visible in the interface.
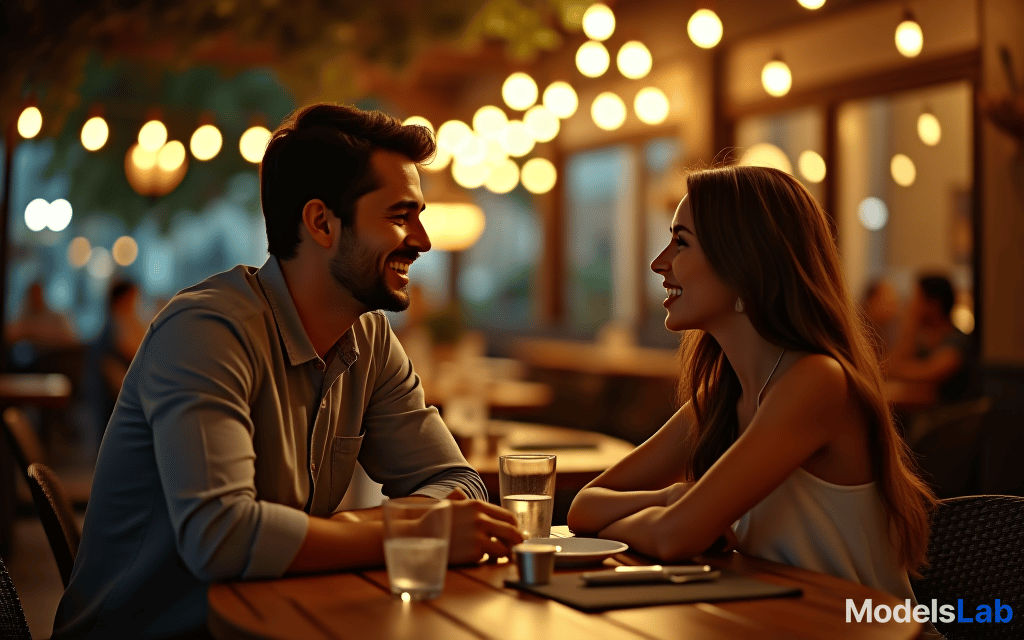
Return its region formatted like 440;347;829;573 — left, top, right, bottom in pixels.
464;420;635;496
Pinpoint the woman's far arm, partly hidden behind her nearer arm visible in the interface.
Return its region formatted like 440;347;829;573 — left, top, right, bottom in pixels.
567;402;693;534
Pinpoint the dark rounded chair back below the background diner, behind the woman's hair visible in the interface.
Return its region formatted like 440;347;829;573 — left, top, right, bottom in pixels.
907;397;992;498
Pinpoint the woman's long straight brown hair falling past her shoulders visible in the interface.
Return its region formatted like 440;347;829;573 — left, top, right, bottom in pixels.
680;166;935;575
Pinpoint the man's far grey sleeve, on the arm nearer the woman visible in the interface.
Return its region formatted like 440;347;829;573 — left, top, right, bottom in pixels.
359;314;487;501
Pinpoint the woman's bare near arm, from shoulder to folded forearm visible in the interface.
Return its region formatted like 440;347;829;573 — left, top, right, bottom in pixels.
600;355;847;561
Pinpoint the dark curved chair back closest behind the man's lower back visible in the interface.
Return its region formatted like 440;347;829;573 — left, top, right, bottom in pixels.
28;462;82;588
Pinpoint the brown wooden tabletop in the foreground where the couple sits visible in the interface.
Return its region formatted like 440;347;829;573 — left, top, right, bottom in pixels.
208;554;921;640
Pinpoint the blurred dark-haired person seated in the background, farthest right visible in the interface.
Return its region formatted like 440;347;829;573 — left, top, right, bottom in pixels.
886;275;972;402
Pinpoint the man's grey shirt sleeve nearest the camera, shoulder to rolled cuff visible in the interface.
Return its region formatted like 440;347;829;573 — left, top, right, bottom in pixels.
139;308;308;582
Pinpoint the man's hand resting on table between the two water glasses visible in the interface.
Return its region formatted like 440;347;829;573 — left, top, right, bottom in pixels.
447;489;522;564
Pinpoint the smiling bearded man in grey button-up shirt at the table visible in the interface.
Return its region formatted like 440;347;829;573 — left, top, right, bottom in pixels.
53;104;521;638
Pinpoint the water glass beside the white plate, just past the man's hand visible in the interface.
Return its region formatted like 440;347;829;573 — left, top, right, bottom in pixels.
498;454;555;539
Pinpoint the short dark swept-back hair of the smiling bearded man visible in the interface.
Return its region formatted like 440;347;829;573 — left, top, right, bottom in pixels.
259;103;435;260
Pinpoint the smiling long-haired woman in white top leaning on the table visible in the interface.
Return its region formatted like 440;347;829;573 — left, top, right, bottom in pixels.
568;166;935;614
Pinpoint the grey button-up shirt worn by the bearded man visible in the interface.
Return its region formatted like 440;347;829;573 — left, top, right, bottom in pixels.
53;257;486;638
